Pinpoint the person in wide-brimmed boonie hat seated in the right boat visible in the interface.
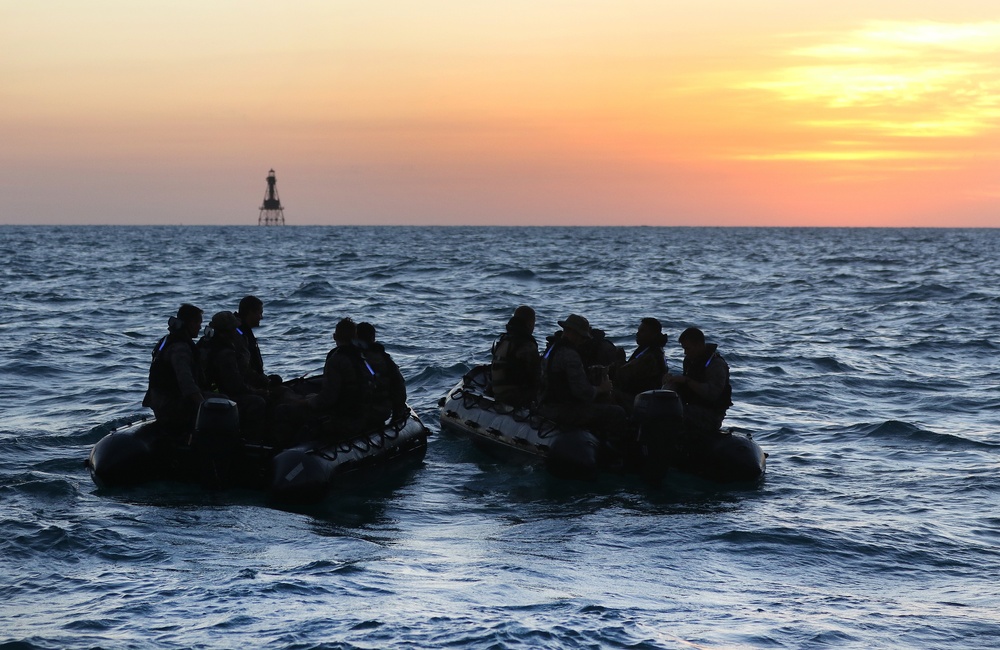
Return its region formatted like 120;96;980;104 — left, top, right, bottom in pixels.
539;314;627;437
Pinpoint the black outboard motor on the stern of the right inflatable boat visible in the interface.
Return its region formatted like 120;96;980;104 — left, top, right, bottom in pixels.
632;390;684;483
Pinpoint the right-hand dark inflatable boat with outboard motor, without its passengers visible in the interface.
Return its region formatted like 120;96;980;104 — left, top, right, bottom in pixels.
438;366;767;483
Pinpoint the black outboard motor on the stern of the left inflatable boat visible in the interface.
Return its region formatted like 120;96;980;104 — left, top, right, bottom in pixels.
191;397;240;487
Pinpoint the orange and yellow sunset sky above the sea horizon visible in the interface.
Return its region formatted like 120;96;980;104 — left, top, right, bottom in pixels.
0;0;1000;227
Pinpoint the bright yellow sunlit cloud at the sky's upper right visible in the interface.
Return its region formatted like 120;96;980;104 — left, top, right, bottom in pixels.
738;21;1000;160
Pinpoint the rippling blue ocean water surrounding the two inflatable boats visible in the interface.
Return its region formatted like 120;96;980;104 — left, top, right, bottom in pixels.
0;226;1000;649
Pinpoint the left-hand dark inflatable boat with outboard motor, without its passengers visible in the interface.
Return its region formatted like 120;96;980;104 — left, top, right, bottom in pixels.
87;378;429;502
